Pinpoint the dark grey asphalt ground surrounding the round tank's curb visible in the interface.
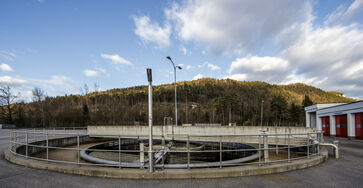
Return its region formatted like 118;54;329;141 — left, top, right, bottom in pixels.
0;129;363;188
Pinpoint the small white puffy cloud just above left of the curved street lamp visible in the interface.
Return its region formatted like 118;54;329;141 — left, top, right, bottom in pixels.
134;16;171;48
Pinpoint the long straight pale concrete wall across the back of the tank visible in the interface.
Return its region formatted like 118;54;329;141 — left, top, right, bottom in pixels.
88;126;316;145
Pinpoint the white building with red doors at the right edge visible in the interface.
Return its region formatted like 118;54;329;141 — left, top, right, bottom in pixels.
305;101;363;139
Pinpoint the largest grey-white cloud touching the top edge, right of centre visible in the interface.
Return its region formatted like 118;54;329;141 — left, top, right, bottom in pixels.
165;0;311;54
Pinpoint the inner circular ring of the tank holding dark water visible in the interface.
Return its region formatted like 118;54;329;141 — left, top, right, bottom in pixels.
81;139;259;168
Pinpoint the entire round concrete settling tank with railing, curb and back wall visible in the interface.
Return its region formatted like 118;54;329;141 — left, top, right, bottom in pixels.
5;126;327;178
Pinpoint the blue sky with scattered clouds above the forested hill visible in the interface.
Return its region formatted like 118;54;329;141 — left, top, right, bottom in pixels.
0;0;363;100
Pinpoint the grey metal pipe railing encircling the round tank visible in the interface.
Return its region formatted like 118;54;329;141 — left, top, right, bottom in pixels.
9;130;322;169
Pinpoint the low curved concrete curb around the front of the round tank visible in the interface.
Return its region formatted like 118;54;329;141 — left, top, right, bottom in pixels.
4;149;328;179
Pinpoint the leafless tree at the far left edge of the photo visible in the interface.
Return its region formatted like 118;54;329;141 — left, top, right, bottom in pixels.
0;85;18;124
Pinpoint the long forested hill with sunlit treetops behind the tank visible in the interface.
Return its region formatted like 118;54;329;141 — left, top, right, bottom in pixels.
0;78;355;127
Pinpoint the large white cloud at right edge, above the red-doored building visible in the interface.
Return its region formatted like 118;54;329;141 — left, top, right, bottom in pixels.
282;24;363;94
